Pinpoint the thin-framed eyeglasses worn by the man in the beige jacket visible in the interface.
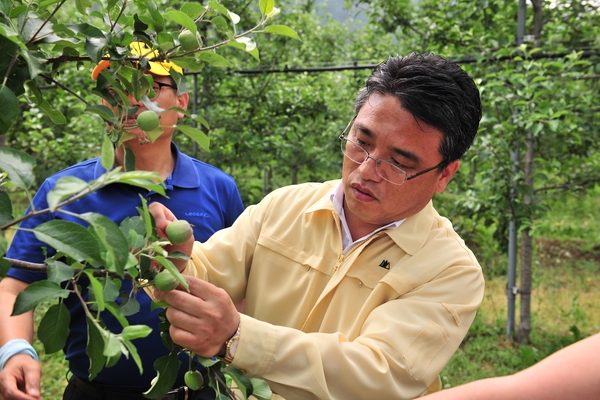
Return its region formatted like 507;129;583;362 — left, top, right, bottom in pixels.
339;116;446;185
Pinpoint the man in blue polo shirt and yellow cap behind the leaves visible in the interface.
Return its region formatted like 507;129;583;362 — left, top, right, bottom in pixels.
0;43;244;400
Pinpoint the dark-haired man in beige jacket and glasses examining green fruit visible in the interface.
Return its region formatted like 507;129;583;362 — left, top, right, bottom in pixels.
151;54;484;400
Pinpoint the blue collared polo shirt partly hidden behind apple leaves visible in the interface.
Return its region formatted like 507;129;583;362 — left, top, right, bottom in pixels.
7;144;244;386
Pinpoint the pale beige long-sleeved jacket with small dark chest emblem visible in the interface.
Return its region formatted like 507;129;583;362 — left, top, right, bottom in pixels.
192;181;484;400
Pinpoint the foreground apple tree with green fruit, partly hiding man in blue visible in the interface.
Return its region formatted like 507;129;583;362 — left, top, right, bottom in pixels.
0;0;298;398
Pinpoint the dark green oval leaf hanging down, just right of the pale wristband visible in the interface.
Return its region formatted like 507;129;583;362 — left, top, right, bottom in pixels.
37;302;71;354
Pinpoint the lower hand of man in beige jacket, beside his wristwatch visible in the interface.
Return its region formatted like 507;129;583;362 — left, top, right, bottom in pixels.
154;276;240;357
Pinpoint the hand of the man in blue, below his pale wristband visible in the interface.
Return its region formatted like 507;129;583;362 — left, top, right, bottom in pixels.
0;354;42;400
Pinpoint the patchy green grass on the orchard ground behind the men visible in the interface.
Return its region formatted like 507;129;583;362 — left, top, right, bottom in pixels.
15;188;600;399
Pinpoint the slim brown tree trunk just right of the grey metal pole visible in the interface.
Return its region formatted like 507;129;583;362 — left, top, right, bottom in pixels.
517;131;535;343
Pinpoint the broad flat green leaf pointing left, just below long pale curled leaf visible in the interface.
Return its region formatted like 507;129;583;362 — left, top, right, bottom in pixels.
33;220;101;261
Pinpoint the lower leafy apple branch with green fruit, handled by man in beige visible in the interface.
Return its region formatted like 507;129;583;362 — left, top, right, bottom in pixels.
0;148;271;400
